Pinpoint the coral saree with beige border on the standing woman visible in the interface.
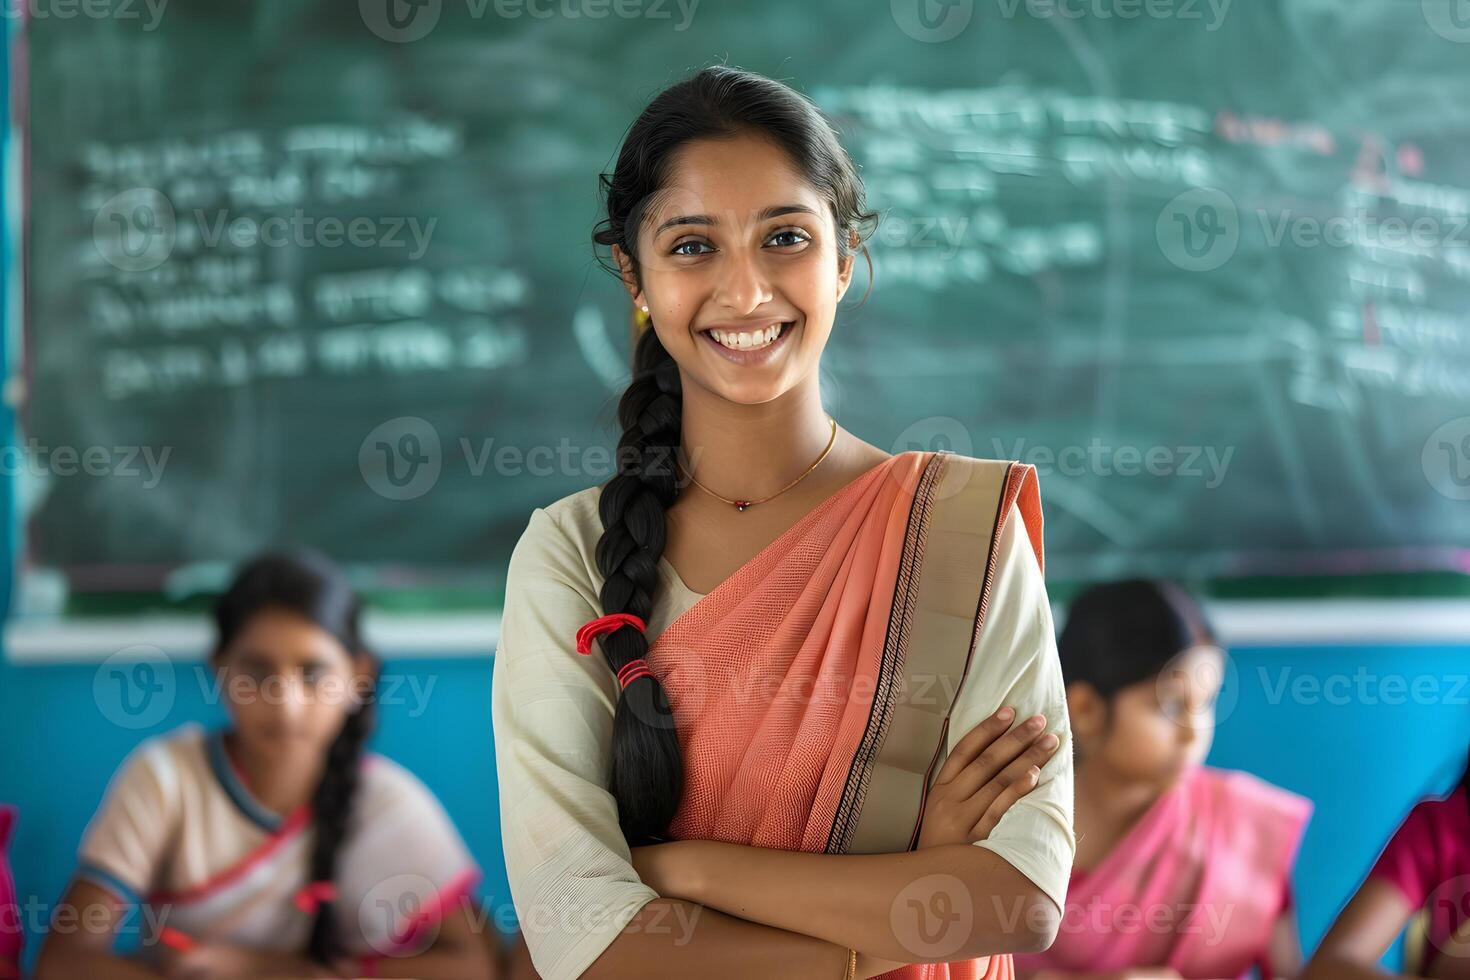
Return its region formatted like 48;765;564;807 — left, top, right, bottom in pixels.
647;451;1042;980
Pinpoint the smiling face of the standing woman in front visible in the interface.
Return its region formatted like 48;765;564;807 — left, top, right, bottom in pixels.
613;135;853;404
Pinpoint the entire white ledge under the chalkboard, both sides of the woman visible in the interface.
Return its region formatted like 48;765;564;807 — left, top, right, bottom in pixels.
4;598;1470;664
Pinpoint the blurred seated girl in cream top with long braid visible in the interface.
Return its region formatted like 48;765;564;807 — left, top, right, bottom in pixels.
37;552;494;980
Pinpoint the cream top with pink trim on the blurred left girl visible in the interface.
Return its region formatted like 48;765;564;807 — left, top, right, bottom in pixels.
78;723;481;958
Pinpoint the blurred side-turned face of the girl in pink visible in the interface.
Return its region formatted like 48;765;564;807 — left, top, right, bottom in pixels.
1073;645;1225;785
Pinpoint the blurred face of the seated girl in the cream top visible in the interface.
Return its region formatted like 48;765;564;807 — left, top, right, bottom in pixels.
215;608;370;754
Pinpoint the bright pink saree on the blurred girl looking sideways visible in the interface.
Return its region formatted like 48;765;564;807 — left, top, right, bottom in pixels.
1016;765;1311;977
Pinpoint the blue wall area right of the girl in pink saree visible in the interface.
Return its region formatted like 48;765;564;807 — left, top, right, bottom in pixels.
1210;646;1470;965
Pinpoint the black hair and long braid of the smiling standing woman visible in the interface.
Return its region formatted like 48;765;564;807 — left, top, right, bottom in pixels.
592;66;876;846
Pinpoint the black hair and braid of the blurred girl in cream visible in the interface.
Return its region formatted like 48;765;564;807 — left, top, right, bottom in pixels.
213;551;376;965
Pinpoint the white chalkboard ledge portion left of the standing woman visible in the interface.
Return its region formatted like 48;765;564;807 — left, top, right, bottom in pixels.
4;610;500;664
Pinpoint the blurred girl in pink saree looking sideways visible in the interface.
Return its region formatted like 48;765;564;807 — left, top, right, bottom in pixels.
1016;579;1311;980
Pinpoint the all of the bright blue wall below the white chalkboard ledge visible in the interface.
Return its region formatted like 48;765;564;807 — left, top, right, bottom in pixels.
0;631;1470;956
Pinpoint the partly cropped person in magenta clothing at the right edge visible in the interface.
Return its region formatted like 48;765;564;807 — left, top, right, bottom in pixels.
1302;767;1470;980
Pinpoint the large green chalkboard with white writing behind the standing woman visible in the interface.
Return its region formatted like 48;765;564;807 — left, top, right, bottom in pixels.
10;0;1470;608
